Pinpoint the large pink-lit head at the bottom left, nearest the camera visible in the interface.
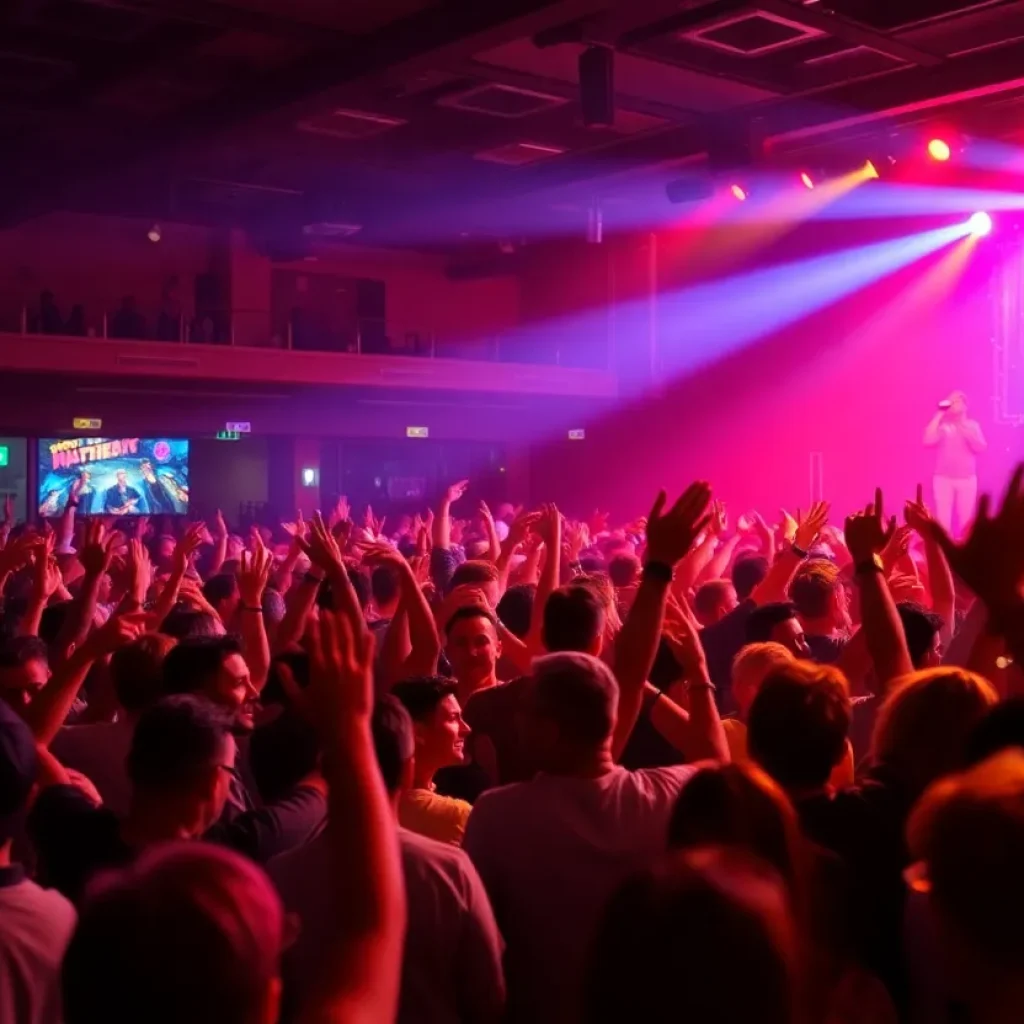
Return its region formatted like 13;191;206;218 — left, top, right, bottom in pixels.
61;843;284;1024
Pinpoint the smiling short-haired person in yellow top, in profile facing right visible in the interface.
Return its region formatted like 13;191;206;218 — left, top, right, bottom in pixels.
391;676;472;846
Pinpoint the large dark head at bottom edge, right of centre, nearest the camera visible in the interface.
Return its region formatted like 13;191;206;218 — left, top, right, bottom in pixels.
583;847;803;1024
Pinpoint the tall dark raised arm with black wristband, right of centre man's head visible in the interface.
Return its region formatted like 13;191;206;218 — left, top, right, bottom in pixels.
611;481;711;759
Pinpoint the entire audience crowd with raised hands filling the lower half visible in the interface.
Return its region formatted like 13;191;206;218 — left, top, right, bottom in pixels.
0;468;1024;1024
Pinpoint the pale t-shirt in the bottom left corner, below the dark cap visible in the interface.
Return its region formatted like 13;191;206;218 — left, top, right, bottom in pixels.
0;866;77;1024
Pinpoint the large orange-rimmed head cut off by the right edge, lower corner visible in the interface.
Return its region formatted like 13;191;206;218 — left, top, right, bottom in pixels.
907;750;1024;1003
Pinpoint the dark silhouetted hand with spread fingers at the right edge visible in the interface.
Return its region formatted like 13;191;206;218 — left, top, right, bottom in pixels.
930;464;1024;610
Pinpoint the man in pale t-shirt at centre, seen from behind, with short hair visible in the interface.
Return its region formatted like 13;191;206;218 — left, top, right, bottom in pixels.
463;652;693;1024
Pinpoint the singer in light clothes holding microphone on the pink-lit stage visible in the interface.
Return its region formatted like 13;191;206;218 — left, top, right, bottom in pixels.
925;391;988;536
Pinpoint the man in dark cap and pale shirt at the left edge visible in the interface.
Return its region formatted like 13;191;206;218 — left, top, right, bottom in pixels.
0;700;76;1024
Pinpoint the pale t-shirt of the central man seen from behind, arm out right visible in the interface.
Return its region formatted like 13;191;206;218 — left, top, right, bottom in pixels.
463;765;695;1024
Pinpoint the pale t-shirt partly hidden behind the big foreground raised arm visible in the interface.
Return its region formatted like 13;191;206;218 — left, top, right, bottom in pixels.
267;828;505;1024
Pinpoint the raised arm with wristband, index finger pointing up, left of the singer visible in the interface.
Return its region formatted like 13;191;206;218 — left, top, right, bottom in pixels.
845;489;913;696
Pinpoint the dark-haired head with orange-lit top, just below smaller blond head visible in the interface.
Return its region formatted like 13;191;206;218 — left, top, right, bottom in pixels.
746;660;850;795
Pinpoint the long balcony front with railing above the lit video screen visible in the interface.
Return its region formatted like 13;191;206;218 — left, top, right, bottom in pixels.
0;309;617;397
